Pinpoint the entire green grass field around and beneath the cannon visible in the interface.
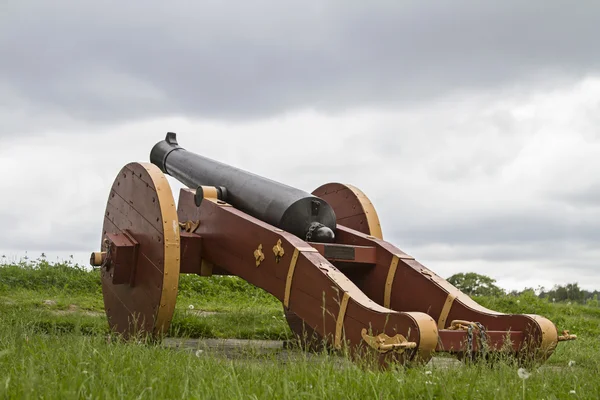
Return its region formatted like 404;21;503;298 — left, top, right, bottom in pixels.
0;261;600;399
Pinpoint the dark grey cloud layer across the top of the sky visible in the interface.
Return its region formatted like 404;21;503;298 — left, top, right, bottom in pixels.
0;0;600;133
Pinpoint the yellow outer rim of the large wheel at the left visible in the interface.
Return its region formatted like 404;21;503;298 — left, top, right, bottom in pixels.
137;163;181;334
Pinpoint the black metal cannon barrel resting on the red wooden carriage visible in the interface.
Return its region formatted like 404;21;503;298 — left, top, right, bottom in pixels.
150;132;336;243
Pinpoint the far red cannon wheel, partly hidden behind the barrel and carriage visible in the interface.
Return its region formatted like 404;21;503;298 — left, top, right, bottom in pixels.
283;183;383;350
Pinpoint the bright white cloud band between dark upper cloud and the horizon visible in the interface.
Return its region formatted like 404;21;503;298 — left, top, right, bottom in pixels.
0;70;600;288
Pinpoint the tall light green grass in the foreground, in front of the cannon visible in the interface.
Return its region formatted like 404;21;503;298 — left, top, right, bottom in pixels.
0;313;600;399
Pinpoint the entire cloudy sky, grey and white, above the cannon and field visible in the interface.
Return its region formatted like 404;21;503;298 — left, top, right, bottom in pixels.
0;0;600;289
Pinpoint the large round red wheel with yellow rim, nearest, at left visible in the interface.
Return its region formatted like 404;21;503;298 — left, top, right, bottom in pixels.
101;163;180;338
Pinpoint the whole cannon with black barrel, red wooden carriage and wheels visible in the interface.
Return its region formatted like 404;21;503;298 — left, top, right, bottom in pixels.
90;132;576;367
